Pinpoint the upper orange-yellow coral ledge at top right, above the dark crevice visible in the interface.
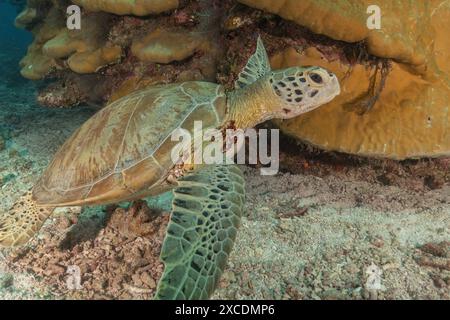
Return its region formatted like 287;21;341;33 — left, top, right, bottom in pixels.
238;0;436;74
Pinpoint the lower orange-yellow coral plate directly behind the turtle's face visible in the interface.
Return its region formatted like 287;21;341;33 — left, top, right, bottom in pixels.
272;48;450;159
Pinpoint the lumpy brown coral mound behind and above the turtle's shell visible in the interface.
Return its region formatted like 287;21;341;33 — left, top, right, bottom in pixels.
16;0;226;107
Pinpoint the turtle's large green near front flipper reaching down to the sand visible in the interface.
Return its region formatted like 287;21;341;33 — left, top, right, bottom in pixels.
155;165;245;300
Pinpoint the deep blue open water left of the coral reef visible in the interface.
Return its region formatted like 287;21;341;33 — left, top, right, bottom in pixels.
0;0;93;142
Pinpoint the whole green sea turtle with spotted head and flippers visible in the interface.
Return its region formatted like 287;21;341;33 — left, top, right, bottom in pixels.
0;38;340;299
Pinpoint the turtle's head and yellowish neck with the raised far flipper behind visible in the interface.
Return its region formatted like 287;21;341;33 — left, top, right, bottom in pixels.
228;37;341;128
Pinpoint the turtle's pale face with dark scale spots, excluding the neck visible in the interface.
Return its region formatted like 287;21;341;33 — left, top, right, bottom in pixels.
269;67;341;119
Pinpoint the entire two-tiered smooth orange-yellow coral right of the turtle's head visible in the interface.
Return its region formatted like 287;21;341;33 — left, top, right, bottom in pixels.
240;0;450;159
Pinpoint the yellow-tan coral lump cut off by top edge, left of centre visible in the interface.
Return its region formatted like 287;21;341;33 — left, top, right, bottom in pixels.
73;0;179;16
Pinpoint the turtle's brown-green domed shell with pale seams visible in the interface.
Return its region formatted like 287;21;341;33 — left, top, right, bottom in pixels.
33;81;226;206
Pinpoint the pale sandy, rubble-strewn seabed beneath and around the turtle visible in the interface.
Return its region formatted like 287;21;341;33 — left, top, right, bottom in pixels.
0;83;450;299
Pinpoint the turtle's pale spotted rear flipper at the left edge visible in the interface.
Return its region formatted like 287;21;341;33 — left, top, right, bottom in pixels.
0;191;55;247
